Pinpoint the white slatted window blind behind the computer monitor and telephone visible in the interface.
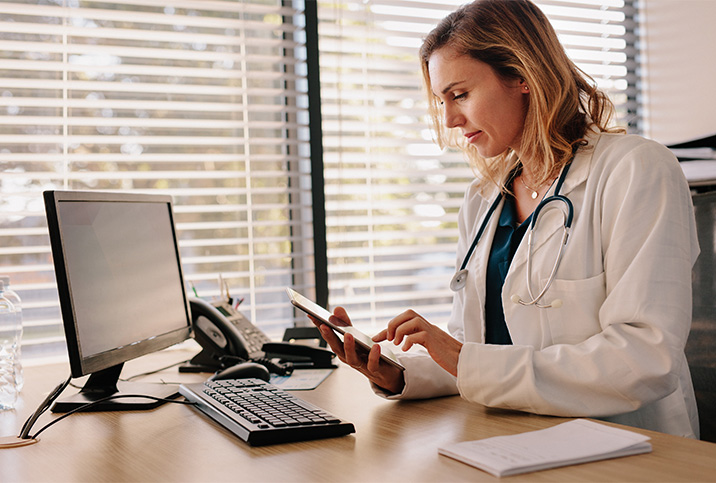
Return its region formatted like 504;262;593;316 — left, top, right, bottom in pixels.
0;0;314;364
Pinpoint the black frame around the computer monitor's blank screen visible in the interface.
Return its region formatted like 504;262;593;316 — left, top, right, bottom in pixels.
43;190;191;378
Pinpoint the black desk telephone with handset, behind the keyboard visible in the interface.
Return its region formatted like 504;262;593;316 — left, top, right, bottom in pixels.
179;298;335;374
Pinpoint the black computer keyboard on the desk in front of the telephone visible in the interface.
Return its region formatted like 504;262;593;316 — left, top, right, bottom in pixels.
179;379;355;446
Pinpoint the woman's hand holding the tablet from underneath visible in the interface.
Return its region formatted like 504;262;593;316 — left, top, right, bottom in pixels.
309;307;405;394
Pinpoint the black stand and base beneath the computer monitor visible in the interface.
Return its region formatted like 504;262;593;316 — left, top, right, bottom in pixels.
52;363;179;413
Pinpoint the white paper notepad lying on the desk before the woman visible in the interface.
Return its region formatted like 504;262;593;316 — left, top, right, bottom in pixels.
438;419;651;476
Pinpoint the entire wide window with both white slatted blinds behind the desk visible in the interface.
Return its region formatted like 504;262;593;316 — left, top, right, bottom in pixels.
0;0;638;364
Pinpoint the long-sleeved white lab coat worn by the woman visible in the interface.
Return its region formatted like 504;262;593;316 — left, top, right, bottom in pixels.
376;132;699;437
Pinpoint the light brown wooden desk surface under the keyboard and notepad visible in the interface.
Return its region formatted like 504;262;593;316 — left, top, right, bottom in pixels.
0;351;716;482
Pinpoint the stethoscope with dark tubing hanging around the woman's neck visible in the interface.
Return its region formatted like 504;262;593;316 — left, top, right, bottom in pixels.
450;162;574;309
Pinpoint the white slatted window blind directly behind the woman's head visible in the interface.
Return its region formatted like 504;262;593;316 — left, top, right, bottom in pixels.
318;0;636;331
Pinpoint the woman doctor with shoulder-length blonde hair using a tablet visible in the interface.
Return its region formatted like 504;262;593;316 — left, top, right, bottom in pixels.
319;0;699;437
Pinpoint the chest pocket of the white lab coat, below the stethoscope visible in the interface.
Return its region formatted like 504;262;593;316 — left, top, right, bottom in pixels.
541;272;606;344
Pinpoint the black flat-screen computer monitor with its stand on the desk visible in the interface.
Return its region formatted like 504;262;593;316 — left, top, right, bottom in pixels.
44;191;191;412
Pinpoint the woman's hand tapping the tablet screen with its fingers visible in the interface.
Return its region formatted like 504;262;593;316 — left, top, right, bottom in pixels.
373;310;462;376
